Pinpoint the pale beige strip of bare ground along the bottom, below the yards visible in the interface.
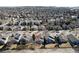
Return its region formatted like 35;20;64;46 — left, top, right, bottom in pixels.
1;48;79;53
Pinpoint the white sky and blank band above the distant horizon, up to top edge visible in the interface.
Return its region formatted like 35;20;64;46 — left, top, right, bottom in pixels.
0;0;79;7
